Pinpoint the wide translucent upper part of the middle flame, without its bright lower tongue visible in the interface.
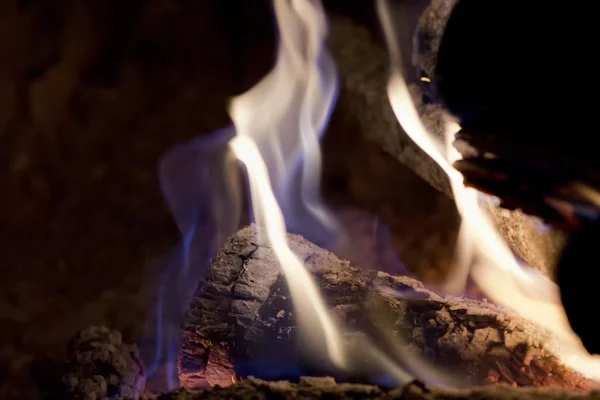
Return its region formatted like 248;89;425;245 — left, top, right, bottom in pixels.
229;0;338;239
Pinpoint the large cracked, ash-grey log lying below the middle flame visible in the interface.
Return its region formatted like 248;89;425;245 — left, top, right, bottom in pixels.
179;227;594;392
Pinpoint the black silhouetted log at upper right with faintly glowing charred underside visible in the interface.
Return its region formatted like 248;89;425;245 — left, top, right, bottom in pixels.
433;0;600;229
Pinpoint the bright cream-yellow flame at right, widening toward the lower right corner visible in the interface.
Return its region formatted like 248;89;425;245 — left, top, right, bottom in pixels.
377;0;600;380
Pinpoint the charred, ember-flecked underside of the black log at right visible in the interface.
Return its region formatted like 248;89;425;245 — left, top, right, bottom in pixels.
454;127;600;231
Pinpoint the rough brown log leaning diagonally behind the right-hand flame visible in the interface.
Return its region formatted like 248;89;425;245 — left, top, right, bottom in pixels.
330;9;565;279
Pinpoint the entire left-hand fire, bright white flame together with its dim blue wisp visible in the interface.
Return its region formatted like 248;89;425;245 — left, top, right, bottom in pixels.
154;0;412;388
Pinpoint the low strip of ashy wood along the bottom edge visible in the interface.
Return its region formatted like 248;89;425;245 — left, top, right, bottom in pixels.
146;378;600;400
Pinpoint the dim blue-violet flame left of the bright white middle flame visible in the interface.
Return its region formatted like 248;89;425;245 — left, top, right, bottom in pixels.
142;127;242;390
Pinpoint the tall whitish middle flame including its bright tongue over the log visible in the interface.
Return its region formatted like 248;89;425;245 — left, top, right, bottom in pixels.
229;0;346;368
